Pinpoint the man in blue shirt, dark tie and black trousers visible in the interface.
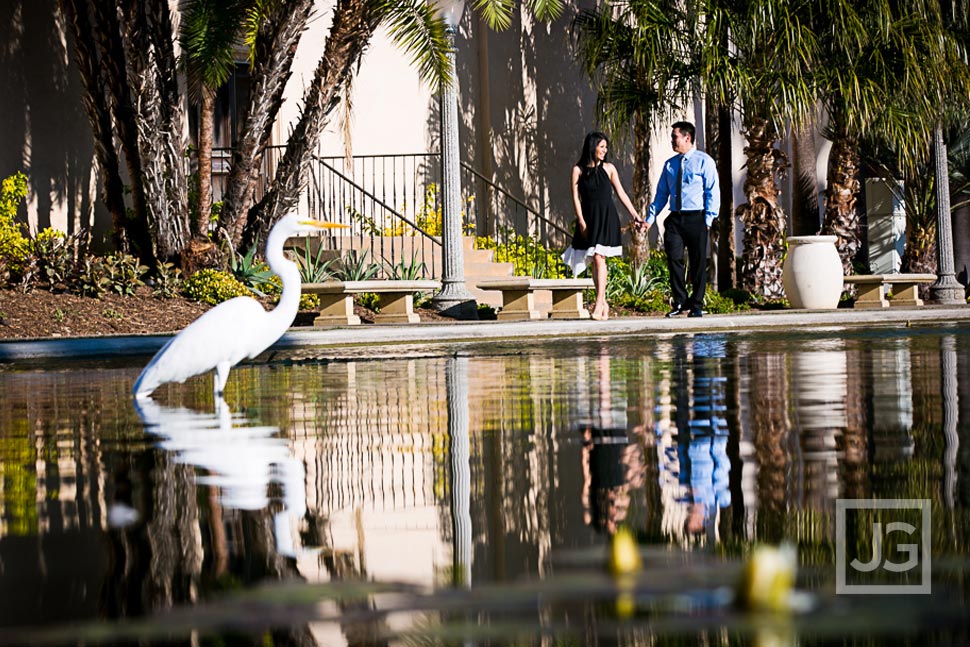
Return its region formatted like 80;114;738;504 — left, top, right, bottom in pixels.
646;121;721;317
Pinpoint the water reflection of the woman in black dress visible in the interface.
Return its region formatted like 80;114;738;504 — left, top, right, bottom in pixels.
581;352;645;534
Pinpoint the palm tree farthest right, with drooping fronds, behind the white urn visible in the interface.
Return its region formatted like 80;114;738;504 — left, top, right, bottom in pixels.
817;0;970;274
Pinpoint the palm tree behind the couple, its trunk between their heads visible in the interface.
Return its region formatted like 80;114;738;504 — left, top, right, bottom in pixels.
573;0;693;265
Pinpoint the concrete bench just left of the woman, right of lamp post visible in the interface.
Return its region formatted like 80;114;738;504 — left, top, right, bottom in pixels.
475;276;593;320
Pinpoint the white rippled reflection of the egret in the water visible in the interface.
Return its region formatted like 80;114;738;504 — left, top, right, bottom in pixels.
135;397;306;557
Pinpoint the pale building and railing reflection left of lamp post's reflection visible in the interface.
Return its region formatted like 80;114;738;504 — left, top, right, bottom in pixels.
292;360;451;584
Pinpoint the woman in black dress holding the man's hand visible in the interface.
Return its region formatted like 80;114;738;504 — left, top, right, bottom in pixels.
562;132;644;321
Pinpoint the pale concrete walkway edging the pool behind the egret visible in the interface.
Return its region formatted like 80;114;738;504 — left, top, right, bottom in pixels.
0;306;970;363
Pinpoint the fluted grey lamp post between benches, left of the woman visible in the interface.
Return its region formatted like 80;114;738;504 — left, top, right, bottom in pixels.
431;0;478;319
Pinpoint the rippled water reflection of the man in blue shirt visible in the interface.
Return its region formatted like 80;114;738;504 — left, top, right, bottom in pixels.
654;335;731;541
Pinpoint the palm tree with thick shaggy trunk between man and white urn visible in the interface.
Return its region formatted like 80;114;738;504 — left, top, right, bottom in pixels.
698;0;818;298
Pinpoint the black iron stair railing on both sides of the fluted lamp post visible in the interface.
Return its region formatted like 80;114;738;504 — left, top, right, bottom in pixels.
213;147;570;278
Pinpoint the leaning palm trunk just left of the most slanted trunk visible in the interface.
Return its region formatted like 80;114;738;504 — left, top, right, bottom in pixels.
220;0;314;248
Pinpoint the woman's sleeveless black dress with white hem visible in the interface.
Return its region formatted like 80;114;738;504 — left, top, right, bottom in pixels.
562;164;623;275
